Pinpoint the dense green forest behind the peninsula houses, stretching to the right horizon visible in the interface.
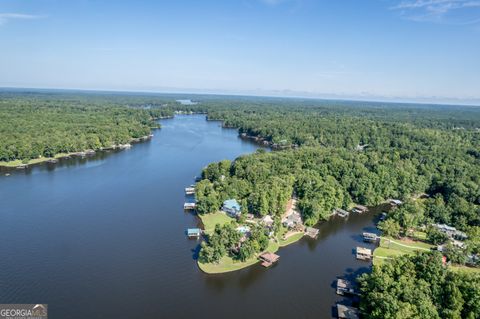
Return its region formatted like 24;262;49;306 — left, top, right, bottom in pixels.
188;99;480;229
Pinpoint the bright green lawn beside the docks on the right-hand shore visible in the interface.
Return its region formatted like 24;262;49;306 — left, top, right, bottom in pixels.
373;237;434;265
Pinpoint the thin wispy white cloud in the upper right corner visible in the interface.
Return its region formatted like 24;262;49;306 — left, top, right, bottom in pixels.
391;0;480;24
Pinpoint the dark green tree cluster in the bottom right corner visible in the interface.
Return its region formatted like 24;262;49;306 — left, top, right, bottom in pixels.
359;252;480;319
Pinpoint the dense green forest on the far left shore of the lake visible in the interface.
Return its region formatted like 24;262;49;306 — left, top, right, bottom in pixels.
0;92;173;162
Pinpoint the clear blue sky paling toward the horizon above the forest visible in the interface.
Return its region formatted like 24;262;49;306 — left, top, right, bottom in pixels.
0;0;480;105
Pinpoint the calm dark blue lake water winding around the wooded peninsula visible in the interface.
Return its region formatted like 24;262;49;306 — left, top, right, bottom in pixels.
0;115;374;319
